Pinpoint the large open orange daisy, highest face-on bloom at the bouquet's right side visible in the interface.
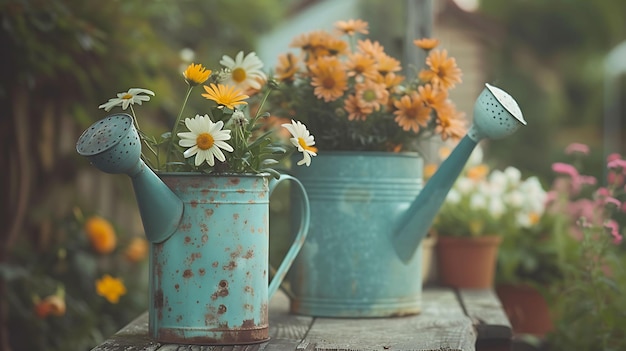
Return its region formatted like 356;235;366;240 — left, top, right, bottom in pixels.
419;50;461;89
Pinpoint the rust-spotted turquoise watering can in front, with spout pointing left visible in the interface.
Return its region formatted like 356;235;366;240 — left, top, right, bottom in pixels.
76;114;309;345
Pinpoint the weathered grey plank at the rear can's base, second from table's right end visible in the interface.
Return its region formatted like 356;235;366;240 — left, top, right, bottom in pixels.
306;289;476;351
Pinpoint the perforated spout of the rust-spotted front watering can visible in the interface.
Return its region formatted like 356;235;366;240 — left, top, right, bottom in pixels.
76;114;183;243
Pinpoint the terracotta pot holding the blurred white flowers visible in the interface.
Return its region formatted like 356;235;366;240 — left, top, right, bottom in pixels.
437;235;502;289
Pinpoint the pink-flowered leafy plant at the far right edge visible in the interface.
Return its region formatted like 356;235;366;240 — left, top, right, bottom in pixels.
546;143;626;351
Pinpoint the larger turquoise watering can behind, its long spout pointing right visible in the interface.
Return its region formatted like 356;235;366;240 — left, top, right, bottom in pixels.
288;84;526;318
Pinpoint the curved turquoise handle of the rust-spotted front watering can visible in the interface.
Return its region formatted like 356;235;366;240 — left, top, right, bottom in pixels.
268;174;311;298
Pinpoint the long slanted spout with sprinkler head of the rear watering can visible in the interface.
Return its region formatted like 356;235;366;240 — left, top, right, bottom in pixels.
393;84;526;261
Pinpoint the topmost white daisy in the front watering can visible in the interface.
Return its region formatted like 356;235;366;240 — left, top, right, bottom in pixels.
220;51;267;91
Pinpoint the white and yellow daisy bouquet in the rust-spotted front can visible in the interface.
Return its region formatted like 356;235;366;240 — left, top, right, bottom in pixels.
99;52;317;177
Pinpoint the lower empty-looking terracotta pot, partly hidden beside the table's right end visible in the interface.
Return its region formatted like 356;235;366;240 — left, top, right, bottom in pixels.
496;284;554;337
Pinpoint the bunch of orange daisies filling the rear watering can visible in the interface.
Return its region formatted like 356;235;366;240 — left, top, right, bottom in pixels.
269;20;466;151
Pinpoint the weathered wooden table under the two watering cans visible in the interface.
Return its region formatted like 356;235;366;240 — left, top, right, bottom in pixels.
92;287;512;351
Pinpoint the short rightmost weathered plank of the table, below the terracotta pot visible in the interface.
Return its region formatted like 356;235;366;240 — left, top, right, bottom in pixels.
458;289;513;340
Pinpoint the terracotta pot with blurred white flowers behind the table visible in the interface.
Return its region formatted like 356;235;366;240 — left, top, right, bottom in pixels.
433;163;545;288
